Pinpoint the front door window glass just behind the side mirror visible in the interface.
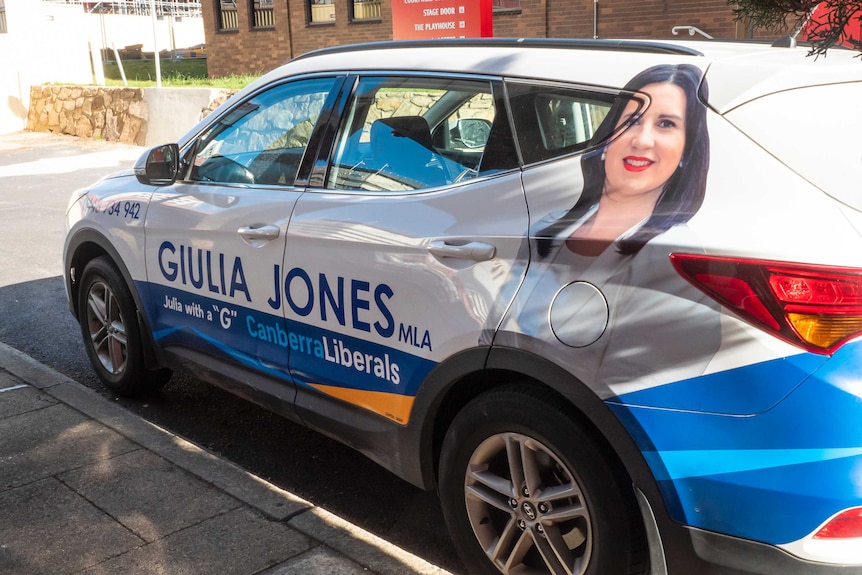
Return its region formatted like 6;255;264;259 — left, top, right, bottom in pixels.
189;78;335;186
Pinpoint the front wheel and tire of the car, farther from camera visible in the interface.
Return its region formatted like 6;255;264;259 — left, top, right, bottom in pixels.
78;257;171;397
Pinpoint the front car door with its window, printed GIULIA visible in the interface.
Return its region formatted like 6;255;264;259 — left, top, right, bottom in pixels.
146;77;342;403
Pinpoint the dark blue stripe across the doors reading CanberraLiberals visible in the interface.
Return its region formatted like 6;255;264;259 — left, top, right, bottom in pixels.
145;284;436;397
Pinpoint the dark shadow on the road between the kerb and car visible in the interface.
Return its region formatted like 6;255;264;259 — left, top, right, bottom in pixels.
0;277;463;573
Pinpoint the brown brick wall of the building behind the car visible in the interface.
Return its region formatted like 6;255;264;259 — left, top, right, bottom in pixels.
202;0;788;77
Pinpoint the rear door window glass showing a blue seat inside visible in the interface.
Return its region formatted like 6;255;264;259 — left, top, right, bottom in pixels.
326;77;496;191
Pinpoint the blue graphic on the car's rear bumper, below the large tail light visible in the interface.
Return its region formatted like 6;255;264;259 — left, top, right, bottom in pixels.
607;342;862;544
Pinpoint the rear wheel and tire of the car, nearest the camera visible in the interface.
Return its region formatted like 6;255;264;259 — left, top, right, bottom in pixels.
439;386;644;575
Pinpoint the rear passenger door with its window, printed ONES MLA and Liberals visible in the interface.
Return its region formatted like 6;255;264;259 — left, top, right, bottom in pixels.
282;75;528;424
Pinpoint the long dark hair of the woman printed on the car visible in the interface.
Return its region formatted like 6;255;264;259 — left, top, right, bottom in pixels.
536;64;709;257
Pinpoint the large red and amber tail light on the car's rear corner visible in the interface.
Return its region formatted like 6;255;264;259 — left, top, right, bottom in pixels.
670;254;862;354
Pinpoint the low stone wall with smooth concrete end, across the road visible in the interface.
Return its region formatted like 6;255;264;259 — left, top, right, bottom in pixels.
26;86;232;146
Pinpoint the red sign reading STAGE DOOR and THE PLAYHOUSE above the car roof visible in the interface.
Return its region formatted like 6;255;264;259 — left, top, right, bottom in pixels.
392;0;494;40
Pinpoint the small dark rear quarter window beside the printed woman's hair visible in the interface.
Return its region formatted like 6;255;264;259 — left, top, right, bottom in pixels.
506;82;640;164
